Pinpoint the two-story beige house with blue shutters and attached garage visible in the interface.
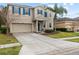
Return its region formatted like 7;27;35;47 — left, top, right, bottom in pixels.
7;4;54;33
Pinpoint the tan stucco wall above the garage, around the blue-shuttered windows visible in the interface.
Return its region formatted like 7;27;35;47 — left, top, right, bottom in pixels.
8;6;33;23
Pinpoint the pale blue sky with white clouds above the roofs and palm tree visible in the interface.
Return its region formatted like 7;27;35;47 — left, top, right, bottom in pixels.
0;3;79;18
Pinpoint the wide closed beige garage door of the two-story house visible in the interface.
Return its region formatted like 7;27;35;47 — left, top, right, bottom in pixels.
11;24;32;33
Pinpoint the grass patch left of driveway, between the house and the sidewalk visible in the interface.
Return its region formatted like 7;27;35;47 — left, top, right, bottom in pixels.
0;34;18;45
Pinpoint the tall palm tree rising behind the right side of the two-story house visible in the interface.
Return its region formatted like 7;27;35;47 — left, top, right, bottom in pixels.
47;4;67;31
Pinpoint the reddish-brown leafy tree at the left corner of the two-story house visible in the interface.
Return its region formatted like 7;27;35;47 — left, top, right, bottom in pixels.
0;7;9;34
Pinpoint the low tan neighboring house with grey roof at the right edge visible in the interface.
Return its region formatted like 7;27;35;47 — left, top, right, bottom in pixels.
55;18;79;32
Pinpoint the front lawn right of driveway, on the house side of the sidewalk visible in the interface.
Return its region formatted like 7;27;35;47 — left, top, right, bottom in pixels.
48;32;79;38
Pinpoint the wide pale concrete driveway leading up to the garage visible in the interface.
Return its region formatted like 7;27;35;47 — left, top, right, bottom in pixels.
13;33;79;55
